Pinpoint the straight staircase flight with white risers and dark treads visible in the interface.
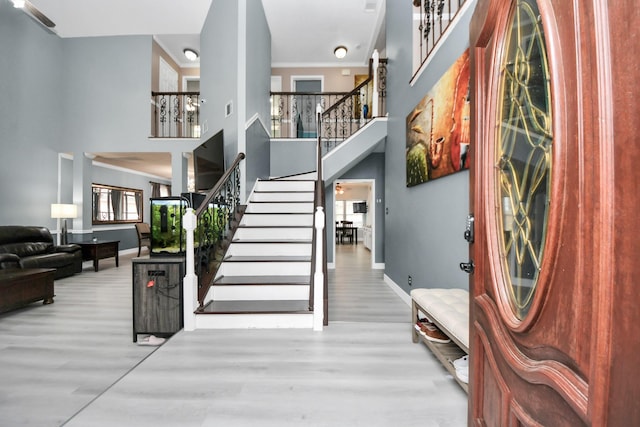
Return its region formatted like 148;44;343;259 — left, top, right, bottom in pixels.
196;177;315;329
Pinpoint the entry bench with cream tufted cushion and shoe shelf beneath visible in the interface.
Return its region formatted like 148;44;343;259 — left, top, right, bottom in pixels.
411;288;469;391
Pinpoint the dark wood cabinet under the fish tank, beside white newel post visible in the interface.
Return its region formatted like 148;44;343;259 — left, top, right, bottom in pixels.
131;257;184;342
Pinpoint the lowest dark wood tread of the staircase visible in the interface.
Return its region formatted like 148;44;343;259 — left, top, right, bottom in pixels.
198;300;310;314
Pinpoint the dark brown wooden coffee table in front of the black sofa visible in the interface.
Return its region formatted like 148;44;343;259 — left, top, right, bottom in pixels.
0;268;56;313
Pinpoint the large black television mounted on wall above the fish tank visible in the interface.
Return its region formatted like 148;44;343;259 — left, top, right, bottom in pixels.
193;130;225;192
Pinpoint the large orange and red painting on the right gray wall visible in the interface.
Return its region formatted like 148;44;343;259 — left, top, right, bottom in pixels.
406;49;470;187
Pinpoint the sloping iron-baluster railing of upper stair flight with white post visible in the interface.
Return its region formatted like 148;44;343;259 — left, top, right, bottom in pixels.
321;51;387;154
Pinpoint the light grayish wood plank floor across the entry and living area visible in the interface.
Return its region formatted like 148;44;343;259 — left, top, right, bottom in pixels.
0;244;467;427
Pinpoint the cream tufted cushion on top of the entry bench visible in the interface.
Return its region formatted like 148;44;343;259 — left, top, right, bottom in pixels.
411;288;469;351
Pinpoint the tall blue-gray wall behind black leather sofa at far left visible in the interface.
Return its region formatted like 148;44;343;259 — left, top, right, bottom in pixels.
0;1;64;229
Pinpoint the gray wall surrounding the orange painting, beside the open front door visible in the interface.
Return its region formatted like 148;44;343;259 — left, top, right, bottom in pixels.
385;1;473;292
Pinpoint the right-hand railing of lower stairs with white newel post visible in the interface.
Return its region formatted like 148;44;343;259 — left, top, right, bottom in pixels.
309;104;329;331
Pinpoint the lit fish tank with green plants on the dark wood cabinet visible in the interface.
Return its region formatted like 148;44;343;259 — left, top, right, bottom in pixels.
150;193;228;256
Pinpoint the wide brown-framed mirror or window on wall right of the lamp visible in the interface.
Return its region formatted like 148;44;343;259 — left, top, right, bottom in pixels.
91;184;142;225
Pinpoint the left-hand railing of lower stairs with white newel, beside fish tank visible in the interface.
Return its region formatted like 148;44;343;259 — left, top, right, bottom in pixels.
183;153;245;330
